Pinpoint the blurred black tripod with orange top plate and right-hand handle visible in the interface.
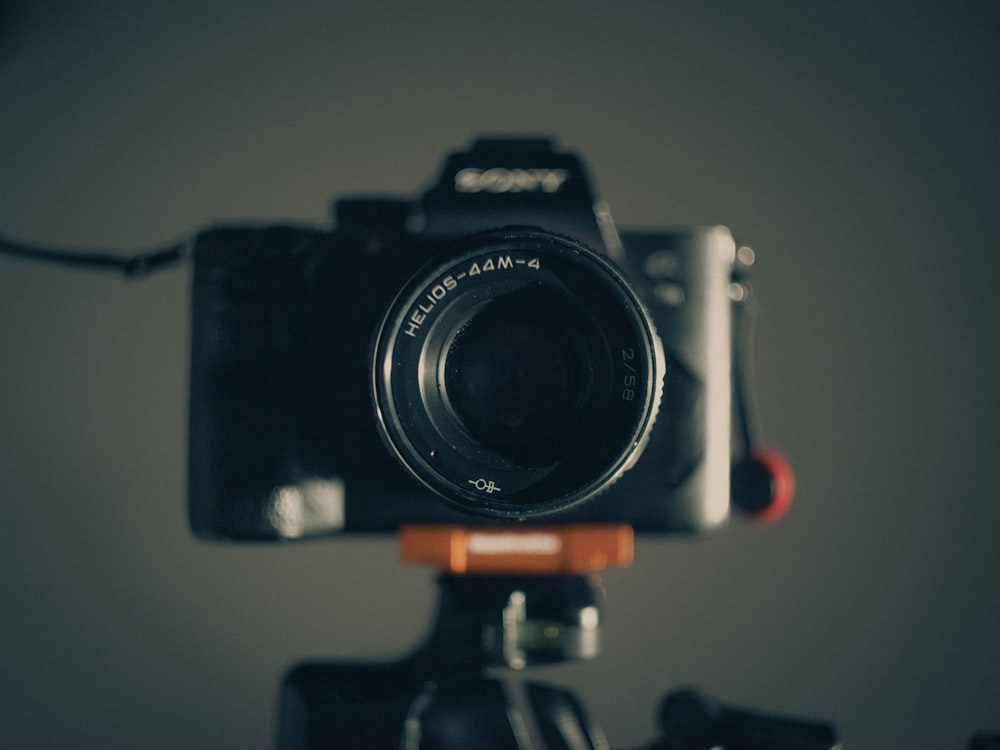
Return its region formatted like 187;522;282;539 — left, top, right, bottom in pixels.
278;527;837;750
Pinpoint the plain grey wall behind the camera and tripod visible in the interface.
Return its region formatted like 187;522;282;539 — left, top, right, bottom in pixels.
0;0;1000;750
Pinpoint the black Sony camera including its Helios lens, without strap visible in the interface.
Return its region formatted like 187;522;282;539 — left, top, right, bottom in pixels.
189;139;736;540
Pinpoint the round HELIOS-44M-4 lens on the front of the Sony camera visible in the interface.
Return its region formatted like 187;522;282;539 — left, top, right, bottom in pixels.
373;230;663;517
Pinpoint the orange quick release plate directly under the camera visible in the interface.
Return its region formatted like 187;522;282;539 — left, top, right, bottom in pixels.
399;524;634;574
